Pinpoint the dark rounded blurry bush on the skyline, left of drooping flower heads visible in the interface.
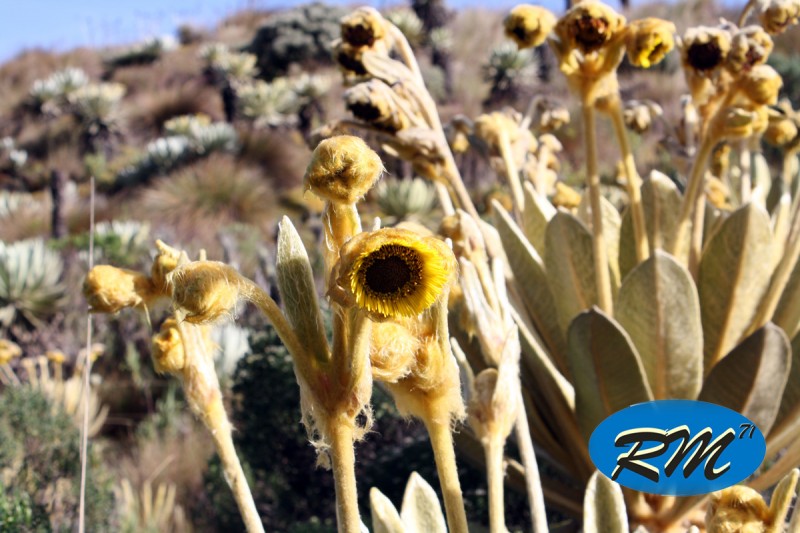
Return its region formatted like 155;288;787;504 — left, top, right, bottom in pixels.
247;3;347;79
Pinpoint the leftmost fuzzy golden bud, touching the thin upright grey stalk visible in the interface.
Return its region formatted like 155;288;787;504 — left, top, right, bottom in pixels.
83;265;153;313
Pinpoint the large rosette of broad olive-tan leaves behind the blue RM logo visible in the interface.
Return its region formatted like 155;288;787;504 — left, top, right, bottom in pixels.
484;160;800;531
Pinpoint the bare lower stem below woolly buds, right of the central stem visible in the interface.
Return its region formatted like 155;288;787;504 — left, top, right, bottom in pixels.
423;415;468;533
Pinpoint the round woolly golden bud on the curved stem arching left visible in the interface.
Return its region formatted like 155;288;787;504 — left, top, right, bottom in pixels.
168;261;244;324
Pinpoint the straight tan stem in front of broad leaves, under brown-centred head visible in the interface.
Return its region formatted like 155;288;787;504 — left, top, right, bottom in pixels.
582;99;614;315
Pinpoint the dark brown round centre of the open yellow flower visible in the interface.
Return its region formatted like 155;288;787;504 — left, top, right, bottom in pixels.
361;244;422;296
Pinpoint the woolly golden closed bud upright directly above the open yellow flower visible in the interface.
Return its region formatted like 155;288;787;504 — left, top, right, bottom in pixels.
303;135;383;204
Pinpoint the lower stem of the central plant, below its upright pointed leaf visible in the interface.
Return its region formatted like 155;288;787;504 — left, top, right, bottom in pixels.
330;420;361;533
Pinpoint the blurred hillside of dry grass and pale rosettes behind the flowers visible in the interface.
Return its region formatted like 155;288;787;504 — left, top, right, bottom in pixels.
0;1;800;532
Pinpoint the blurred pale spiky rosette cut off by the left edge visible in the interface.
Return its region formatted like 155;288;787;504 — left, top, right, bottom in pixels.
0;239;66;328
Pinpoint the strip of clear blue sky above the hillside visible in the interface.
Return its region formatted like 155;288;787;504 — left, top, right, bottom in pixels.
0;0;563;62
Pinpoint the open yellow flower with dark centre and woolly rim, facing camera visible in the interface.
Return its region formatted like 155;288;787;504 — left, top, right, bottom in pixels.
337;229;456;318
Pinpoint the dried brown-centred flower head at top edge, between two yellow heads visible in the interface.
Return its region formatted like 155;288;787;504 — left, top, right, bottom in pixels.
555;0;625;54
